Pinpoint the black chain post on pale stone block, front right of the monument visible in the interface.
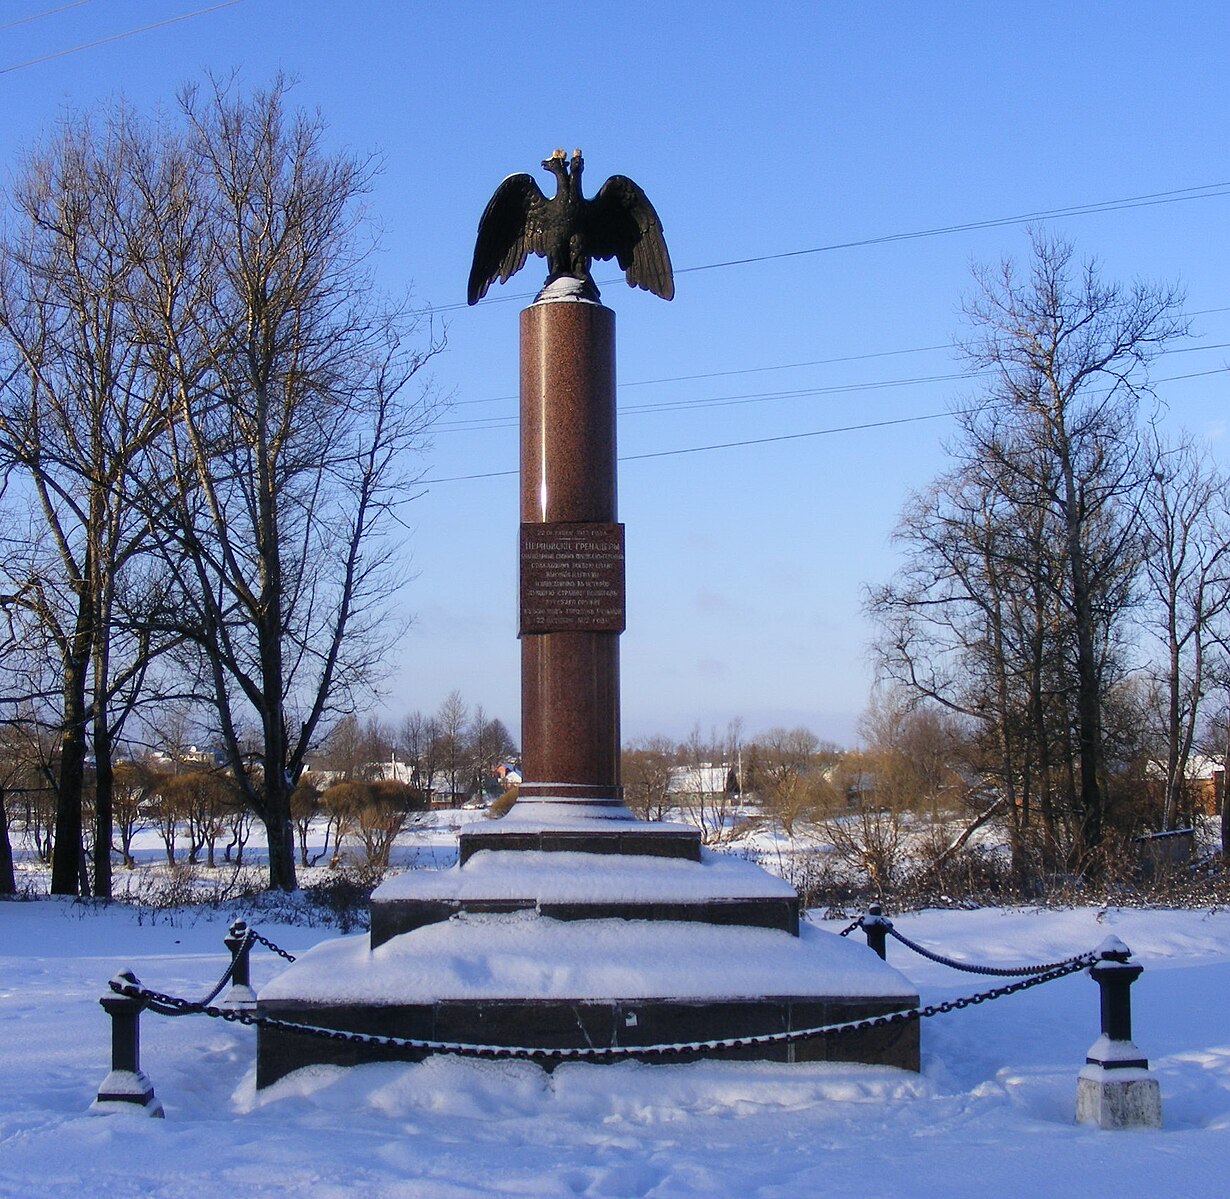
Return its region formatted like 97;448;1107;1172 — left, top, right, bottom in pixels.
1076;937;1161;1128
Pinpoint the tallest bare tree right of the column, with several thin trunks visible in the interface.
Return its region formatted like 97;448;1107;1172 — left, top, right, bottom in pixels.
871;234;1186;867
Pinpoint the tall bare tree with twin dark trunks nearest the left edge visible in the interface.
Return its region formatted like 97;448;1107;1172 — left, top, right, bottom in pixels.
0;107;178;895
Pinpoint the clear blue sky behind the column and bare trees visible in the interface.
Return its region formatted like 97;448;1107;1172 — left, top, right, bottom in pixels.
0;0;1230;740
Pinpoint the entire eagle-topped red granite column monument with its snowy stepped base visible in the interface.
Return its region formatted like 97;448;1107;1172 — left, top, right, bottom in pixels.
257;150;919;1087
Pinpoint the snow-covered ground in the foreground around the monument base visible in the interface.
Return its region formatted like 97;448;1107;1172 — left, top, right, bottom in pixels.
0;900;1230;1199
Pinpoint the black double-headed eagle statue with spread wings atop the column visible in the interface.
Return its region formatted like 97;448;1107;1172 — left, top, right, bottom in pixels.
467;150;675;304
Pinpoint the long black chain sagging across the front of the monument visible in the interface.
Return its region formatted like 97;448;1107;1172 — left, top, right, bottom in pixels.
109;954;1095;1061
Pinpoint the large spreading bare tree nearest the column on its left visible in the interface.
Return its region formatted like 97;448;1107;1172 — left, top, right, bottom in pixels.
134;80;439;889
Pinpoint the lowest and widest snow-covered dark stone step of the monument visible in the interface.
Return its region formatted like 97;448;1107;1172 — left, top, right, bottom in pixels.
256;912;919;1087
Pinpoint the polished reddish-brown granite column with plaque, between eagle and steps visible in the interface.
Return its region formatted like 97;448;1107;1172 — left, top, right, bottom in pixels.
519;288;626;815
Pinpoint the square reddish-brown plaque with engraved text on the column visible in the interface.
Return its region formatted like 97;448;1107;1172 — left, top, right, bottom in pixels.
518;523;625;635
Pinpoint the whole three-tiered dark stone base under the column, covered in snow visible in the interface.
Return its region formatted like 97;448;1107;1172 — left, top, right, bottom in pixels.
257;804;919;1087
